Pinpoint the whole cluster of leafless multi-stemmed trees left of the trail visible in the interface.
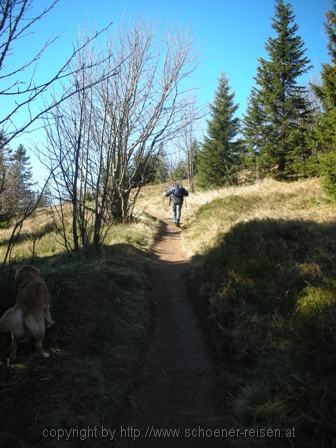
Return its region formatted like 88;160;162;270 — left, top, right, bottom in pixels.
43;23;198;249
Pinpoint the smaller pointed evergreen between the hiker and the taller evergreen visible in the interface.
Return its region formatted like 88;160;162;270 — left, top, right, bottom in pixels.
196;74;241;188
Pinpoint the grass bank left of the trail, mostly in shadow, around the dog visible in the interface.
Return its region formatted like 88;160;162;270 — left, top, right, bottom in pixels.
0;212;158;448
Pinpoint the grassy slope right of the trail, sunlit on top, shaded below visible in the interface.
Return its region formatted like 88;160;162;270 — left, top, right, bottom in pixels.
183;180;336;447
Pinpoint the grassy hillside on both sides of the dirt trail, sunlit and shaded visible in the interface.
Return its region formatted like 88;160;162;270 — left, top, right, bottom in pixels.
0;180;336;448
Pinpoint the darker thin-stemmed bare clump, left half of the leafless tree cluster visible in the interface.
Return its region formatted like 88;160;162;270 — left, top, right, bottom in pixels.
44;35;124;251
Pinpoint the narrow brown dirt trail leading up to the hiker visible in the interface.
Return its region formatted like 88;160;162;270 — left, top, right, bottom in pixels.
123;219;226;447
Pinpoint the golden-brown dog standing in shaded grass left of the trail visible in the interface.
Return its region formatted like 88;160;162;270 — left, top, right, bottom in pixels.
0;265;55;361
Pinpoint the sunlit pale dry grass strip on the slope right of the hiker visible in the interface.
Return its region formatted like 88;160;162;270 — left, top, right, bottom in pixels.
182;179;336;256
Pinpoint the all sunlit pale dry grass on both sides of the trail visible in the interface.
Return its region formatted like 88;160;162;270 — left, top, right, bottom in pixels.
0;179;326;260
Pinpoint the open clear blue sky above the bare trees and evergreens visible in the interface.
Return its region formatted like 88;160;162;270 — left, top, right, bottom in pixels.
7;0;333;178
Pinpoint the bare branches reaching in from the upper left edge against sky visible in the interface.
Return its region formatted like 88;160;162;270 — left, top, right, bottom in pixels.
0;0;115;144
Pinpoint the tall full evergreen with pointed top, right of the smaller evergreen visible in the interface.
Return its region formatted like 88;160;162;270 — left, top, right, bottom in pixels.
244;0;312;178
